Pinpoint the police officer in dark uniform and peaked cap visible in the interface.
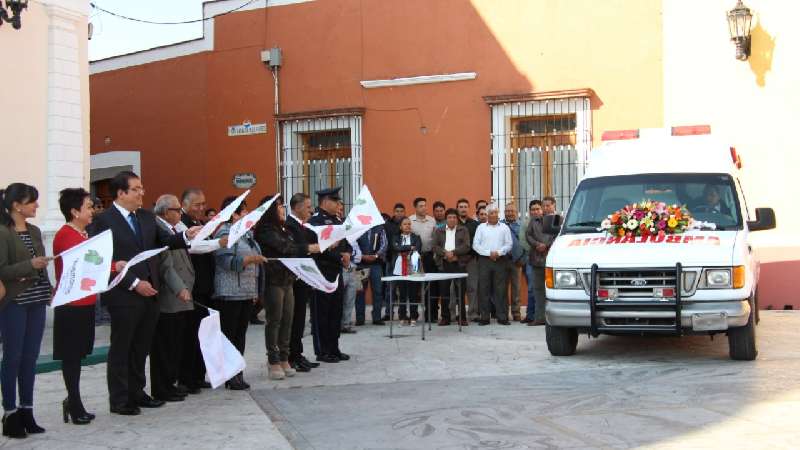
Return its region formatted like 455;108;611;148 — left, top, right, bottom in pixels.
308;186;353;363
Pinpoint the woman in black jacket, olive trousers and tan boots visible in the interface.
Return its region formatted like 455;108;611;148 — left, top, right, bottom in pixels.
256;197;319;380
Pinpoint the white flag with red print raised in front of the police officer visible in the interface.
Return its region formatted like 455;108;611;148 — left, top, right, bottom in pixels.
306;185;385;251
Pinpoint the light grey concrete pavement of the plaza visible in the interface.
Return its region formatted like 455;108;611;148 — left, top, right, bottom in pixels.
0;311;800;449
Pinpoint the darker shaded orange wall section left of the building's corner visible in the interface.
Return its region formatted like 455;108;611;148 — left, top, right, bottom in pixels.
90;54;208;200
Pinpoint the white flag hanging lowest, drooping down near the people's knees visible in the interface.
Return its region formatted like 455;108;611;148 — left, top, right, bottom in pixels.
197;308;245;389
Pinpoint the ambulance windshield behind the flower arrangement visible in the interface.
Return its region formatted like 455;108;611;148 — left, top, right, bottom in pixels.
563;173;742;233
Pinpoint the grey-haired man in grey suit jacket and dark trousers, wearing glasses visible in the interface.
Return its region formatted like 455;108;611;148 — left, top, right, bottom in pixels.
150;194;202;402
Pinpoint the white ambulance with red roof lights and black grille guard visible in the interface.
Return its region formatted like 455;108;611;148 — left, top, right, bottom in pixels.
545;125;775;360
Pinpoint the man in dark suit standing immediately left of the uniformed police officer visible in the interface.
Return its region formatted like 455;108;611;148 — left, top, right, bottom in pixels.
286;192;319;372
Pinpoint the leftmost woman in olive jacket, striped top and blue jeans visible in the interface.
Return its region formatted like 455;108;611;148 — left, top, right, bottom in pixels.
0;183;52;438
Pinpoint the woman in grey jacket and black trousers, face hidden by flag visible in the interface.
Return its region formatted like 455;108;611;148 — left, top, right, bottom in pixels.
214;197;266;391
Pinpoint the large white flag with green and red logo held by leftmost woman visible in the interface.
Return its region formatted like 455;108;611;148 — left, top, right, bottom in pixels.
50;230;114;308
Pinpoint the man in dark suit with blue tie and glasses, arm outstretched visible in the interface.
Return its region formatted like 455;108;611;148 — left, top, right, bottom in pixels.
92;171;199;415
